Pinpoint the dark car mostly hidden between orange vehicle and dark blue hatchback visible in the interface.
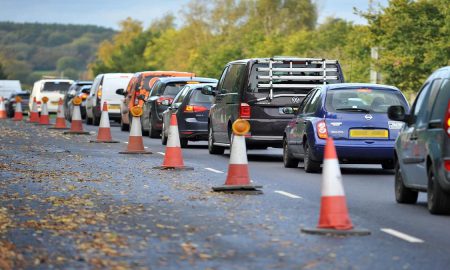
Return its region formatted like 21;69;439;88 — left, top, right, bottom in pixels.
141;77;217;138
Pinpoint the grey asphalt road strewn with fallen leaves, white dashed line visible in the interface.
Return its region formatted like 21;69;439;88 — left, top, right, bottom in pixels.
0;118;450;269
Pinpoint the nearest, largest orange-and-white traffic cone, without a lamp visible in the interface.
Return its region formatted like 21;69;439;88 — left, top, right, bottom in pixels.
302;138;370;235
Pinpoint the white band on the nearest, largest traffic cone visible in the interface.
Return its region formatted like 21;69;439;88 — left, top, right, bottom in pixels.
322;159;345;196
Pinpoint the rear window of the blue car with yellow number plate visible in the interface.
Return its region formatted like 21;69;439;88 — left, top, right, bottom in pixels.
326;88;407;113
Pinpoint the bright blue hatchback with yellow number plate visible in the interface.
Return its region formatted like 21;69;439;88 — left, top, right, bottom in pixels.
283;83;409;172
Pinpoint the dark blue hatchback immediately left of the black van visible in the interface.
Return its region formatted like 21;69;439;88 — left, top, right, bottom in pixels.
161;83;216;147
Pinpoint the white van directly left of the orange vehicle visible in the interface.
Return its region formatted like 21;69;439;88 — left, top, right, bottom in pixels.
86;73;133;126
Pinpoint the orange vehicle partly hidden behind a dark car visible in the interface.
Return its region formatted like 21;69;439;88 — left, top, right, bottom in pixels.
116;71;195;131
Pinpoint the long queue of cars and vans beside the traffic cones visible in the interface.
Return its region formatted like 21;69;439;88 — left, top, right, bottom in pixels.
1;57;450;214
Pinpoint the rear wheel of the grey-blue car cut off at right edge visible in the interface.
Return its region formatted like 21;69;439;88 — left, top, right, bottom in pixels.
427;165;450;215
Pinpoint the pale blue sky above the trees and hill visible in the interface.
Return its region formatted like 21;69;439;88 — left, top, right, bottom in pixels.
0;0;388;29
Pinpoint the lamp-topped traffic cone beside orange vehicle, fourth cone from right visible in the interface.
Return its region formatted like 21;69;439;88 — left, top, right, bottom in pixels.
119;106;152;154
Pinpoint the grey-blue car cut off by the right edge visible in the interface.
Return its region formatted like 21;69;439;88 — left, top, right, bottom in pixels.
389;66;450;214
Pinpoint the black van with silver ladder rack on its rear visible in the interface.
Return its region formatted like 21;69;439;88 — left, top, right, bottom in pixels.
204;57;344;154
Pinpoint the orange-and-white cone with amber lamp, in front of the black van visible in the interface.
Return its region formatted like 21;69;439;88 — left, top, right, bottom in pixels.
213;119;262;191
